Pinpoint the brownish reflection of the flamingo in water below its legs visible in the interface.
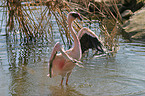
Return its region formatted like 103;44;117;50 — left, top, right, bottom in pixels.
49;86;85;96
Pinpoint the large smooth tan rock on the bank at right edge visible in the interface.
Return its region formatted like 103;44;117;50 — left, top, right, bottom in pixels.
122;7;145;41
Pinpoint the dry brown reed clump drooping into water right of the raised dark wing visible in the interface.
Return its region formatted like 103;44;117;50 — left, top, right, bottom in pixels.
90;1;120;52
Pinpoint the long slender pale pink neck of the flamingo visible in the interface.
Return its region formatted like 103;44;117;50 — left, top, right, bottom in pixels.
68;20;82;59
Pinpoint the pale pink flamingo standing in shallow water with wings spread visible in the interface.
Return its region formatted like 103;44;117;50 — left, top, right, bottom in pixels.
47;12;104;85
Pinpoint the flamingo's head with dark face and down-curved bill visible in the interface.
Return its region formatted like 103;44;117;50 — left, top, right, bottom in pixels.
67;12;82;21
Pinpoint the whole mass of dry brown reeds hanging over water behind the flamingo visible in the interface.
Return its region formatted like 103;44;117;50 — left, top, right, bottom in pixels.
1;0;122;52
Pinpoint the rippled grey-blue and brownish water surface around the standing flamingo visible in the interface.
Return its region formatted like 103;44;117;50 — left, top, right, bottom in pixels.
0;7;145;96
